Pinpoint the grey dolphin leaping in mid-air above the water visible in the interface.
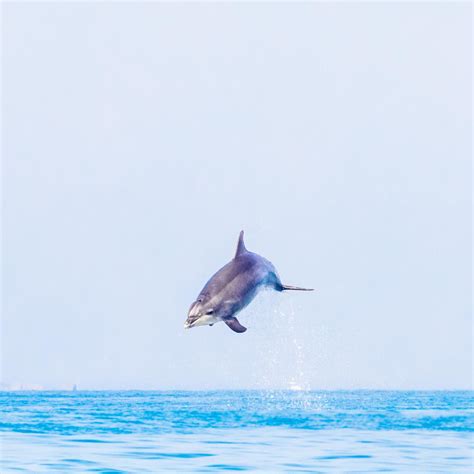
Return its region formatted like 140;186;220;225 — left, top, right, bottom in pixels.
184;231;313;333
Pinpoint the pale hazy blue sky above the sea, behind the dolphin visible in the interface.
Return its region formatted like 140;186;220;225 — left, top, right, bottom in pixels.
1;2;473;389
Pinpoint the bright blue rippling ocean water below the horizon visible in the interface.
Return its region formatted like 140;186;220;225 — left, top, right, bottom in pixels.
0;391;474;473
